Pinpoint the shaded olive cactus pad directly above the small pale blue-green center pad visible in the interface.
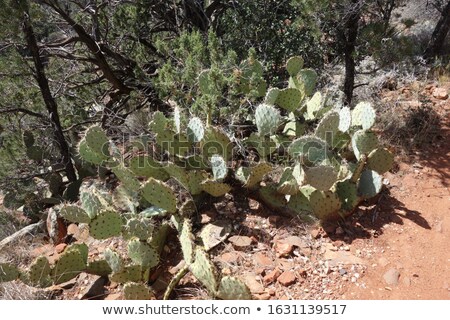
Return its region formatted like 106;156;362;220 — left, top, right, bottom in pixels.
201;127;233;161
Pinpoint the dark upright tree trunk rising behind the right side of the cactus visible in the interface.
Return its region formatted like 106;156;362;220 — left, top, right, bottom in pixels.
344;0;361;104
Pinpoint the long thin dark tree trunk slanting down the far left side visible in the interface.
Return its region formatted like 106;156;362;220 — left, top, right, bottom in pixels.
19;3;77;181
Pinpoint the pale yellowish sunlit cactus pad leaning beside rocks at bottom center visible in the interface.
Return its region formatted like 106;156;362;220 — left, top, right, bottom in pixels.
189;248;219;293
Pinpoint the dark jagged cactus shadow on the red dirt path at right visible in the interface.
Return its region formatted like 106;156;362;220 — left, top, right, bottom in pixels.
324;189;431;243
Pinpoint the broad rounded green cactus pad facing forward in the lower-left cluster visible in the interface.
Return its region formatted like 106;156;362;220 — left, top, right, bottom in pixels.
89;209;122;239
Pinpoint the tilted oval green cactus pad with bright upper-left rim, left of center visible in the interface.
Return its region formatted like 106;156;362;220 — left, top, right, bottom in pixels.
141;178;177;213
